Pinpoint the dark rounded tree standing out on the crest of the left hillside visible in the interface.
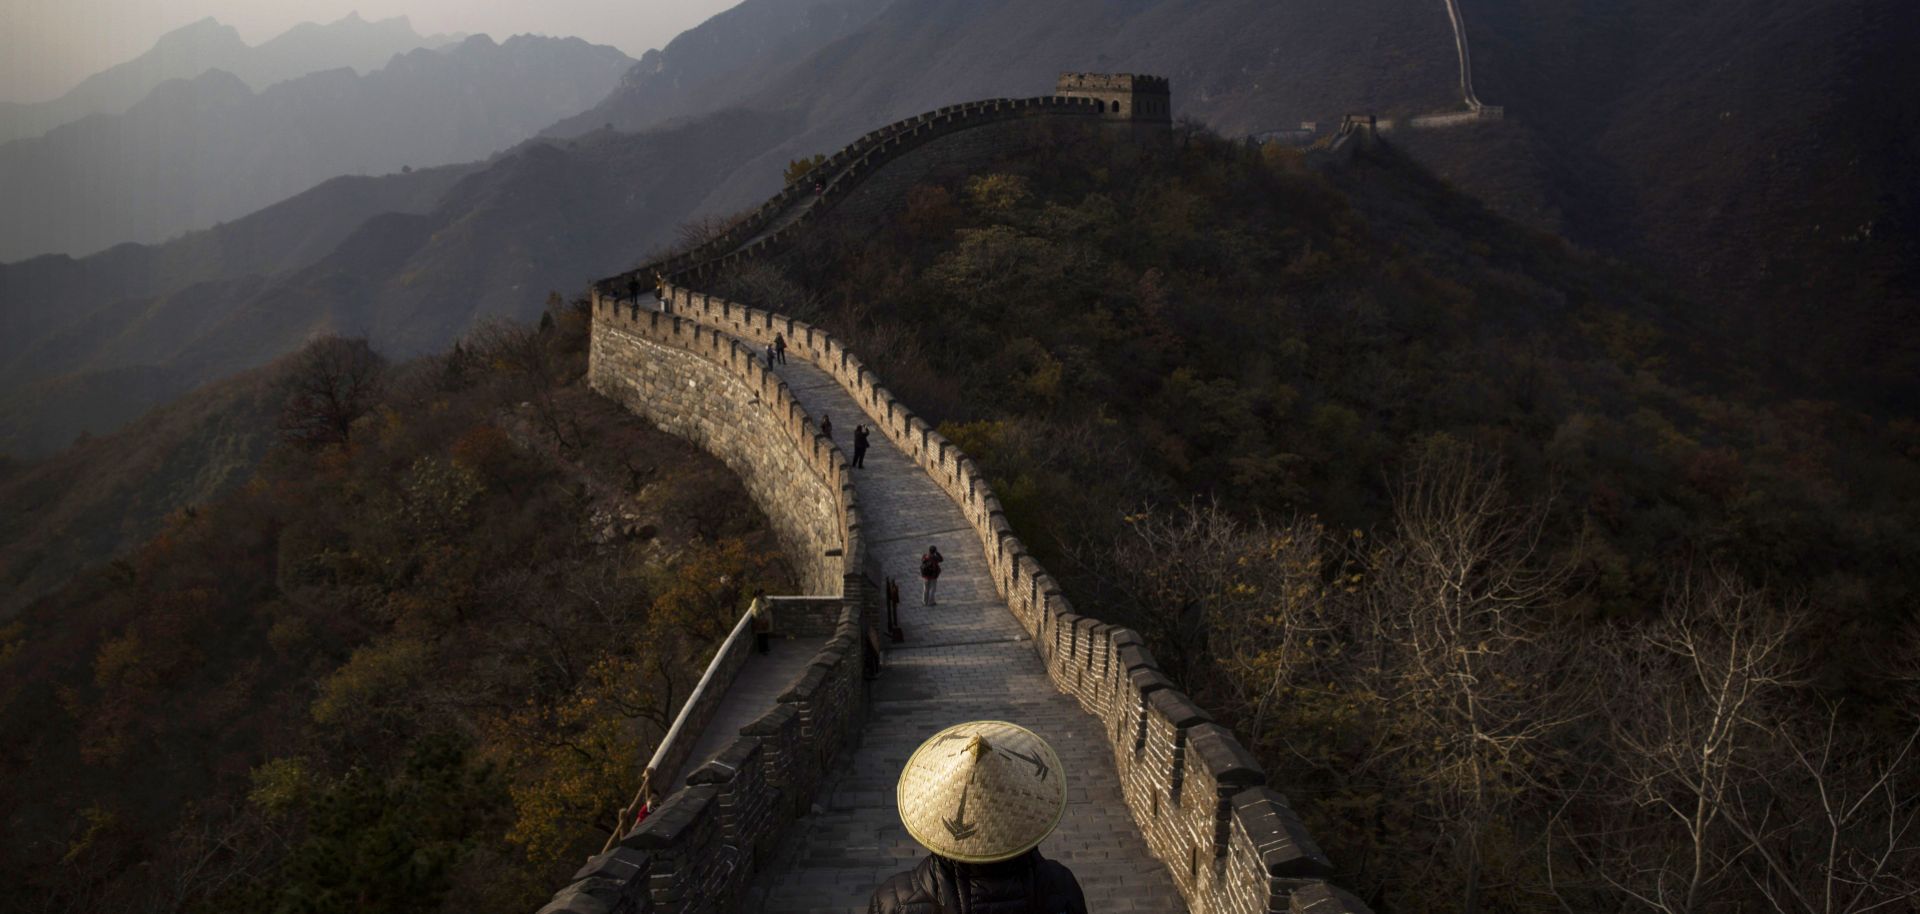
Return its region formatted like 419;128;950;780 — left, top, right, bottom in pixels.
278;336;386;447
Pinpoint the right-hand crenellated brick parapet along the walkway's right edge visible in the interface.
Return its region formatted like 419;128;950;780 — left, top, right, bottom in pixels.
664;286;1365;914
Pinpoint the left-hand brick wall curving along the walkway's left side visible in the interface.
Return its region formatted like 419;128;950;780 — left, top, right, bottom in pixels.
541;296;876;914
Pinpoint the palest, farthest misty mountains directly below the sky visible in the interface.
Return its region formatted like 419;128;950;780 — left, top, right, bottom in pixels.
0;36;630;257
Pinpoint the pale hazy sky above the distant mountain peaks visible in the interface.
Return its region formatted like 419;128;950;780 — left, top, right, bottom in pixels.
0;0;739;102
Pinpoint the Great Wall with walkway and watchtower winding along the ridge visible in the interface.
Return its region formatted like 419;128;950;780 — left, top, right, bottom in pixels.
541;73;1371;914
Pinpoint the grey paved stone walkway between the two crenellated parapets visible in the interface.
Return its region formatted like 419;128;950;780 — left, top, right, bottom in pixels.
747;359;1187;914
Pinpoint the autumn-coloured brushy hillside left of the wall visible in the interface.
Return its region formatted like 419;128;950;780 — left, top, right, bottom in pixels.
0;300;793;914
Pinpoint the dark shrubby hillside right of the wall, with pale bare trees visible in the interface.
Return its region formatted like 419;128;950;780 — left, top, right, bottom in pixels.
716;129;1920;912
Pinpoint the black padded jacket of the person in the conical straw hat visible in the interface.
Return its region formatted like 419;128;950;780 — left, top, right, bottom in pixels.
866;851;1087;914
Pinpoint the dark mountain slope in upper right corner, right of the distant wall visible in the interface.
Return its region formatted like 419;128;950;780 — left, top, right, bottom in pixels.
1411;0;1920;409
